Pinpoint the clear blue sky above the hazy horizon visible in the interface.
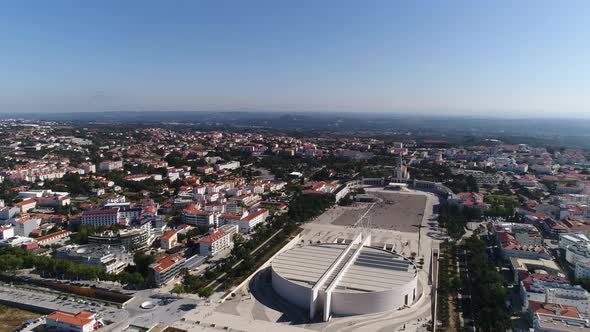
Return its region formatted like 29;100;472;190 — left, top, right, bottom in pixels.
0;0;590;116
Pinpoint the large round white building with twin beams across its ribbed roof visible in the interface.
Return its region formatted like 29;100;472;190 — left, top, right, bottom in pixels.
272;233;417;321
